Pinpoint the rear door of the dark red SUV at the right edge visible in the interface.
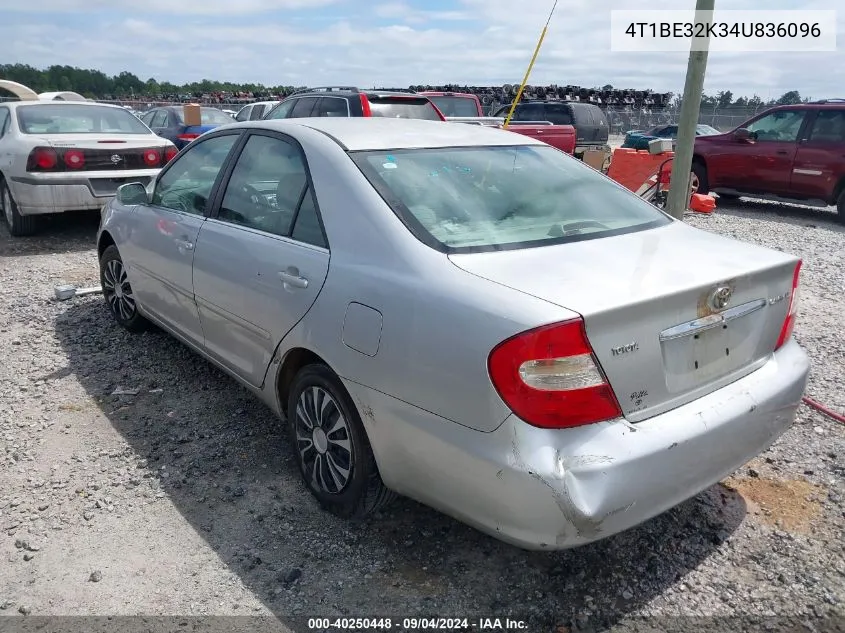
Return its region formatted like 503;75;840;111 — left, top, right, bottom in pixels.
790;107;845;202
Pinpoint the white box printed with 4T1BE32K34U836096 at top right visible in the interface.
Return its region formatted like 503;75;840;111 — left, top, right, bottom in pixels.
610;10;836;52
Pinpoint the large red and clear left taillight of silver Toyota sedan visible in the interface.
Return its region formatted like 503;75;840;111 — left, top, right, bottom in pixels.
487;318;622;429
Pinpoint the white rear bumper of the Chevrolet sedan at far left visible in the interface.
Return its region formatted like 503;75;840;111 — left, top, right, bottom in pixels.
9;169;159;215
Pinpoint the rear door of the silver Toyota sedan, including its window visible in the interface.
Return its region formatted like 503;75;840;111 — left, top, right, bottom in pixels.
193;132;329;387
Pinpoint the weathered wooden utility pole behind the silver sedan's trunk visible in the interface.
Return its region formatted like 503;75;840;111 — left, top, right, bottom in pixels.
666;0;714;220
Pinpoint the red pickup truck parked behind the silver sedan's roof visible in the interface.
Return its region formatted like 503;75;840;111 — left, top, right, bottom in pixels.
419;92;575;154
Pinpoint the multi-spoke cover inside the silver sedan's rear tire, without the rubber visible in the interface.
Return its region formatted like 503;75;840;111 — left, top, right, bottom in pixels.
294;385;353;494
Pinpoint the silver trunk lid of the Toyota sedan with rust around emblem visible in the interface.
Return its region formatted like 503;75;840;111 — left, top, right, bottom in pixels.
449;222;798;422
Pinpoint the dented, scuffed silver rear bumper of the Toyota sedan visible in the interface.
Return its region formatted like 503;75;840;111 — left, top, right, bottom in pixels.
347;341;809;549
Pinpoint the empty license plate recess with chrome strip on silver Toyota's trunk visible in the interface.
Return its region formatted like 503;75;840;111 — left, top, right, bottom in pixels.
660;302;765;393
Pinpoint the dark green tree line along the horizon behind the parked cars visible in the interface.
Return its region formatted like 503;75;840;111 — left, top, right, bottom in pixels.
0;64;809;109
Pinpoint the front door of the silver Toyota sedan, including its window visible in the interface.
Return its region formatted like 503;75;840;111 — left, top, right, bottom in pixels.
124;132;239;345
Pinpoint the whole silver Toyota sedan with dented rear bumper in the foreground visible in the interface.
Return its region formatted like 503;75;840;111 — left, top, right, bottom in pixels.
98;118;809;549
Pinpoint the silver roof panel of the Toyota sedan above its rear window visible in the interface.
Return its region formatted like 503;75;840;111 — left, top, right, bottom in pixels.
237;117;545;151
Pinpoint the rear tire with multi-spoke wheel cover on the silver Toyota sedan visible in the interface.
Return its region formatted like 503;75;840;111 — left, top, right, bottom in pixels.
287;364;396;519
